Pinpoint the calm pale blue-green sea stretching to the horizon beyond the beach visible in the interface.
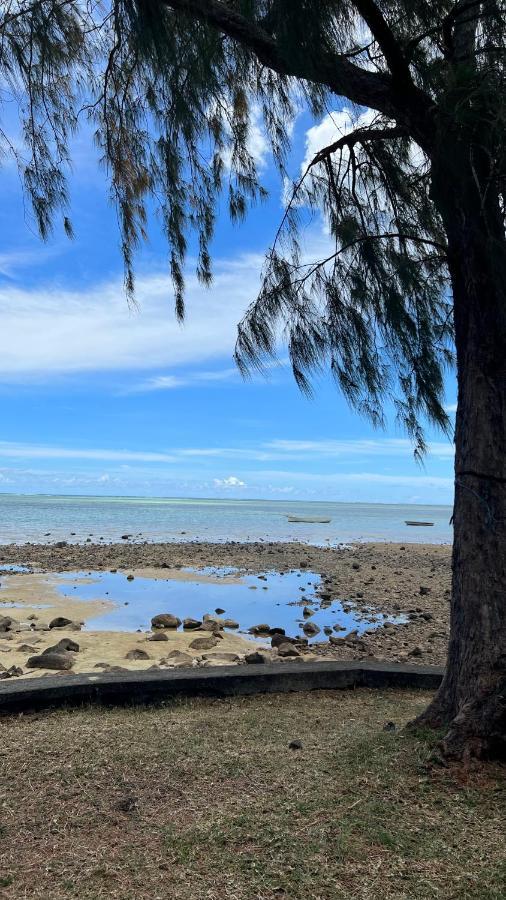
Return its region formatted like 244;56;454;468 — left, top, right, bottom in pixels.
0;494;452;544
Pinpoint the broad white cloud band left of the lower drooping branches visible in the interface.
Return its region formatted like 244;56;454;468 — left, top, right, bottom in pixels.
0;255;263;380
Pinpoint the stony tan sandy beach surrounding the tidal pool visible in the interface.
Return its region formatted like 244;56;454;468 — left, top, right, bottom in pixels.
0;541;451;677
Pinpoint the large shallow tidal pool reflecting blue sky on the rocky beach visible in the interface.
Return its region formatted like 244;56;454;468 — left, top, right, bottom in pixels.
55;568;404;642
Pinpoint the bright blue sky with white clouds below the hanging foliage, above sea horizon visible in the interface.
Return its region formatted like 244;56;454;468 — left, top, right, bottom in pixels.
0;105;455;503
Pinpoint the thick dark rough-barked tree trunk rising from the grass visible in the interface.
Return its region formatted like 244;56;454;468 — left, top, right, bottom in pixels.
418;153;506;759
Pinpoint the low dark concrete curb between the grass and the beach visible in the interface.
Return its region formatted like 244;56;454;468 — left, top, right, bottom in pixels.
0;661;444;714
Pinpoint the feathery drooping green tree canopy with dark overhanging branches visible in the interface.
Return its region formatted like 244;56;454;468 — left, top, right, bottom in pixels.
0;0;506;450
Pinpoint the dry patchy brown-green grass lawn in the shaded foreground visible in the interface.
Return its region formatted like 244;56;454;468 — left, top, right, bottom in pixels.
0;689;506;900
